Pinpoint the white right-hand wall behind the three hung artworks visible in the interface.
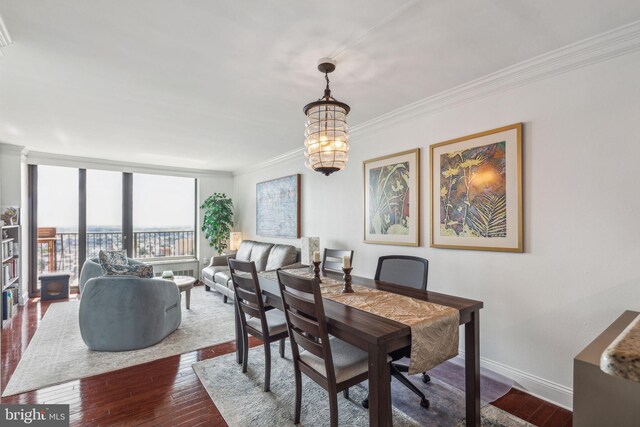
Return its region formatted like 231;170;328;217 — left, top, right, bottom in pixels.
234;47;640;406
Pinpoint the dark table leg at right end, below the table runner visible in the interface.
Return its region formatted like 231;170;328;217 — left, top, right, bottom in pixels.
464;310;480;427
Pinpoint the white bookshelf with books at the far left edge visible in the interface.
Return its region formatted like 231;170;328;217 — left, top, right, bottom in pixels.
0;225;21;328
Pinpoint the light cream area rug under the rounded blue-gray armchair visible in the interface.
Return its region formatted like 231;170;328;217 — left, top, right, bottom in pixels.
2;286;235;397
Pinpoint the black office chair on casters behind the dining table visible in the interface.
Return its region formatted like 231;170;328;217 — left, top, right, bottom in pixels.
362;255;431;408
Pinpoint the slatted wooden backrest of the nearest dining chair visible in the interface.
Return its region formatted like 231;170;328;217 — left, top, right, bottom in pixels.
278;270;336;383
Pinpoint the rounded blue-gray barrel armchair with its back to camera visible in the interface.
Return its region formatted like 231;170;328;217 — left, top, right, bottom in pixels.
79;258;182;351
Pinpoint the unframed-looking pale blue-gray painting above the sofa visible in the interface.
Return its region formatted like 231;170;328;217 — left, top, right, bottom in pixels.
256;174;300;239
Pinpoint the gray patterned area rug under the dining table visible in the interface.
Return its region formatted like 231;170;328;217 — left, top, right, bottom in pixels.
193;344;530;427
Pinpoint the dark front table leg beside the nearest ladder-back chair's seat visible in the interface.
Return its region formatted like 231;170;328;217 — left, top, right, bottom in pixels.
369;344;392;427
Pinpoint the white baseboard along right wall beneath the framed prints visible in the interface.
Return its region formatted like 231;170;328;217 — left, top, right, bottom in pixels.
453;350;573;410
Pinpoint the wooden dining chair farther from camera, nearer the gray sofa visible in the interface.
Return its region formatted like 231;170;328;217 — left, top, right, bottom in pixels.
228;258;289;391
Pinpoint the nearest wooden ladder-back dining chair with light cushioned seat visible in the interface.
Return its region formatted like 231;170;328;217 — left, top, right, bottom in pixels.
278;270;380;427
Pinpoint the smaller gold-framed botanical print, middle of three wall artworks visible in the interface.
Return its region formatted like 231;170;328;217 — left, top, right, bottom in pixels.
362;148;420;246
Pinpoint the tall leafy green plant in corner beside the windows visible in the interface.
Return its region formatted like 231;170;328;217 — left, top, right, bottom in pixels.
200;193;233;255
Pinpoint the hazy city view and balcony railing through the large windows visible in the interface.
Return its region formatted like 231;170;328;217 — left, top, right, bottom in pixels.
37;166;196;285
